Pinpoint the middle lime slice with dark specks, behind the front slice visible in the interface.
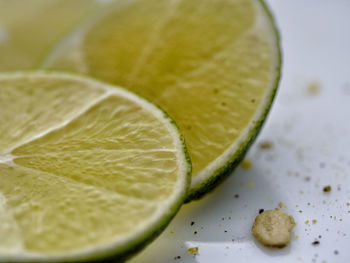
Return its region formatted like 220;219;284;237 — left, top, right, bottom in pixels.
43;0;281;200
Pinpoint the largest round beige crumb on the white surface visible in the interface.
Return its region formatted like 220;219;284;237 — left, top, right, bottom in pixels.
252;209;295;248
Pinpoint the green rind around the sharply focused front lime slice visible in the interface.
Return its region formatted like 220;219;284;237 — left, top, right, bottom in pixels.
0;70;192;263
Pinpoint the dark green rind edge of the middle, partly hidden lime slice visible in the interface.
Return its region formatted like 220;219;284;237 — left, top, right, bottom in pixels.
185;0;282;203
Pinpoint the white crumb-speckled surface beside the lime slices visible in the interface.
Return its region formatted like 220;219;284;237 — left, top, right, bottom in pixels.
130;0;350;263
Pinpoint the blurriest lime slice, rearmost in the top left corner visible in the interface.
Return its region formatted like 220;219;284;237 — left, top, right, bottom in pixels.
0;0;115;71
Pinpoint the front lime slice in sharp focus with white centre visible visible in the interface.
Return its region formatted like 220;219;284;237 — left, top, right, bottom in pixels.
0;72;191;262
